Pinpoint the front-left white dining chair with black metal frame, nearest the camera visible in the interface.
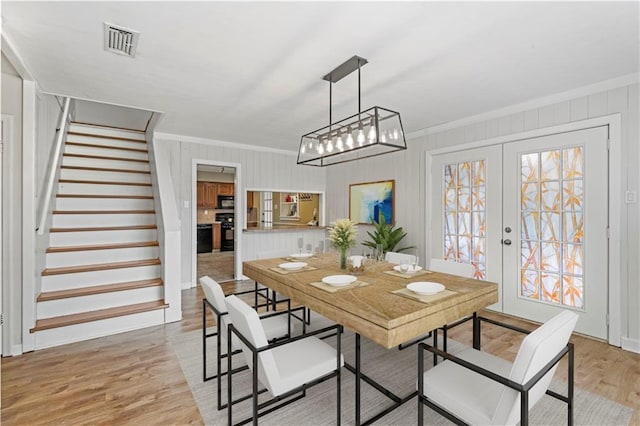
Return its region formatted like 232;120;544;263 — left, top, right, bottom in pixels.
227;295;344;425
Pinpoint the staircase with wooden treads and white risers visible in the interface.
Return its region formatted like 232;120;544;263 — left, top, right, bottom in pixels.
30;123;168;348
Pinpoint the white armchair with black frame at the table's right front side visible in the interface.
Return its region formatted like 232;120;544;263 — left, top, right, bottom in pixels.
418;310;578;426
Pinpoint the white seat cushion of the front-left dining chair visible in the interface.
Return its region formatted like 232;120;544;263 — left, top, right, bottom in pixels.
269;337;344;396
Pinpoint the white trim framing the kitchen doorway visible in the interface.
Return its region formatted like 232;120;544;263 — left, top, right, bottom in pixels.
189;158;244;287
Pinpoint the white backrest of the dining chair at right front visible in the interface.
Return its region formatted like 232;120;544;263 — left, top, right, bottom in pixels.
492;311;578;425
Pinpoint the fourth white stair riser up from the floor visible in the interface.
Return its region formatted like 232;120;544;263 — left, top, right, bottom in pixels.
46;247;158;268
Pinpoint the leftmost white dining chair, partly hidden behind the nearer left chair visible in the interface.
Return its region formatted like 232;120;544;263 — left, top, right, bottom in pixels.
199;276;306;410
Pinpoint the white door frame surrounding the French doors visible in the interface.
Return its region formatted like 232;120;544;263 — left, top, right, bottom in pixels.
424;113;628;346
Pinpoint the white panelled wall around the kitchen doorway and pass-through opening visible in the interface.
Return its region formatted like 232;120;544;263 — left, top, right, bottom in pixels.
154;133;325;287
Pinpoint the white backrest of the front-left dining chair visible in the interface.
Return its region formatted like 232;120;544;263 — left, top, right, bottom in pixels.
227;295;280;394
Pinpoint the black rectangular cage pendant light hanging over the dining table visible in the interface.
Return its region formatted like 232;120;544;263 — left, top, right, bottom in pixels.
298;56;407;167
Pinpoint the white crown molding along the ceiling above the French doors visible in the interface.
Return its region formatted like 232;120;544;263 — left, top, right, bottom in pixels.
406;73;640;139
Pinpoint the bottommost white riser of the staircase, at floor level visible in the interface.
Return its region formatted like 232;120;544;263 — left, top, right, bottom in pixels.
35;309;164;349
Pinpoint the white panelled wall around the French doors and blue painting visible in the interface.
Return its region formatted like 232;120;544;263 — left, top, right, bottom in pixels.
327;79;640;348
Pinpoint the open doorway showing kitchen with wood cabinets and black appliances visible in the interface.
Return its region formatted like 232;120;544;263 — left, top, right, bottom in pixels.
194;163;241;282
